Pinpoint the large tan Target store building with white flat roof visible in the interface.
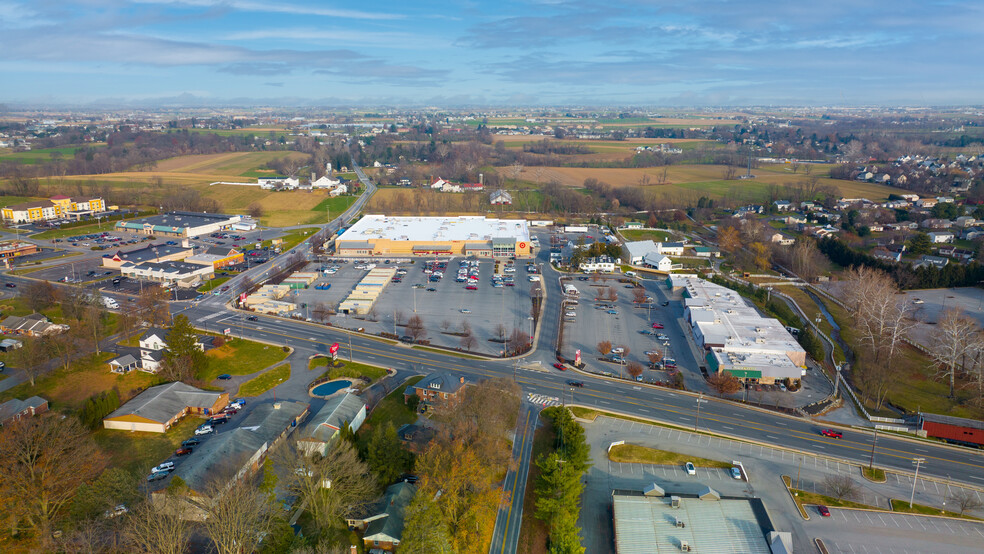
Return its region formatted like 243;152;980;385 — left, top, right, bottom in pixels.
335;215;533;258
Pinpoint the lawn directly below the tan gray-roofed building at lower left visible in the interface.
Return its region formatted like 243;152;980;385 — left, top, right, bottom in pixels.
92;415;203;474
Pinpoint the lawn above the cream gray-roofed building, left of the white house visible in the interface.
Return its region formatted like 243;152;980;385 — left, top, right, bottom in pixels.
0;352;160;410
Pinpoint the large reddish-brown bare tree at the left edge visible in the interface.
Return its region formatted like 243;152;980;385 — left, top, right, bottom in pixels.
0;416;105;535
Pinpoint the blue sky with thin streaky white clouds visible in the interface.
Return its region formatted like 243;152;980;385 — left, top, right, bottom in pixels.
0;0;984;107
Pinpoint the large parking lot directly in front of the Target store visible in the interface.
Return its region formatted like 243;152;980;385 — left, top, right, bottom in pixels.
291;258;532;355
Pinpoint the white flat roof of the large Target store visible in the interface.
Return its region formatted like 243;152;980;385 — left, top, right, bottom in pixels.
339;215;530;242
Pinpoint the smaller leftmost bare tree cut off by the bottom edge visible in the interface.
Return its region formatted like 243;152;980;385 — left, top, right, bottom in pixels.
123;496;191;554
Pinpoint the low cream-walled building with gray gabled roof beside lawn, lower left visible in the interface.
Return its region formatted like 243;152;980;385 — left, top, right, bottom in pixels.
103;381;229;433
